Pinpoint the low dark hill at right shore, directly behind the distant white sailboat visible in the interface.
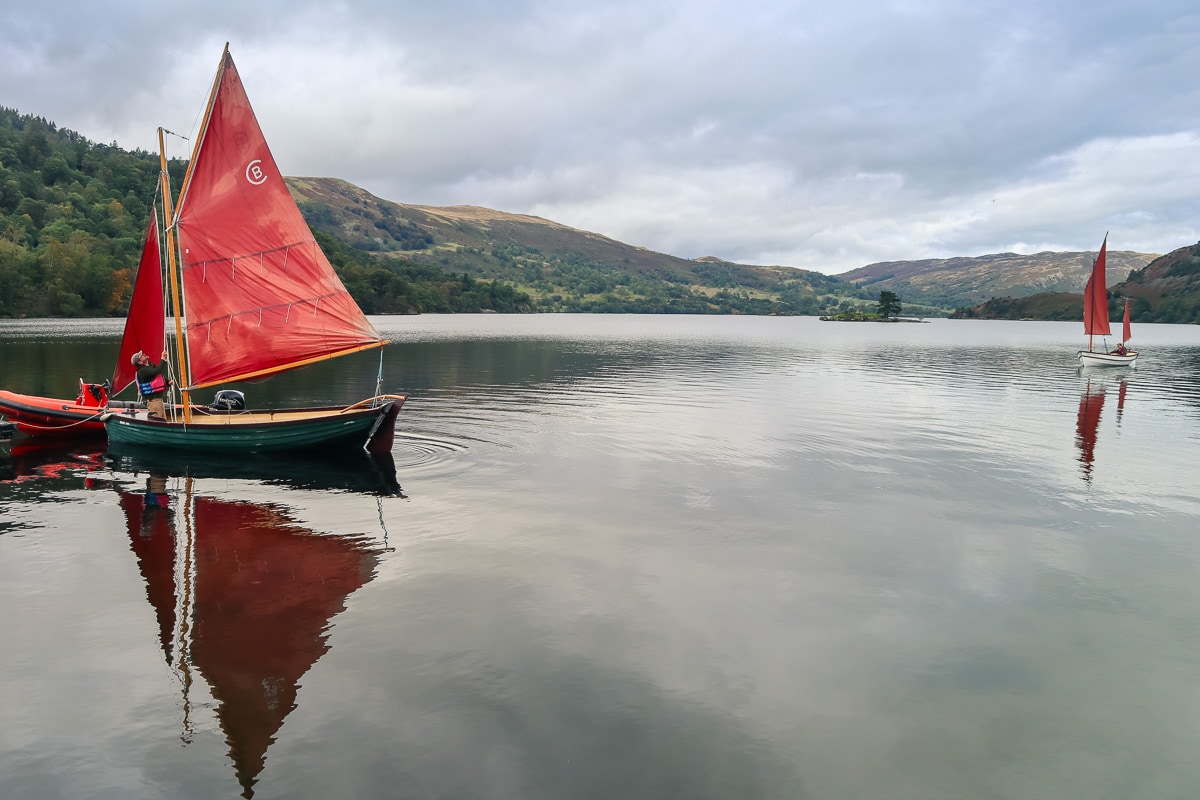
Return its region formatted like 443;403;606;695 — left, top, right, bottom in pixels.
953;242;1200;324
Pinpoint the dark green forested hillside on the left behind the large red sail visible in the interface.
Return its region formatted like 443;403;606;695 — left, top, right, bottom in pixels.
0;108;533;317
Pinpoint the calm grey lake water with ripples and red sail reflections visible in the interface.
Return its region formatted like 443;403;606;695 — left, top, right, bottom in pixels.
0;314;1200;800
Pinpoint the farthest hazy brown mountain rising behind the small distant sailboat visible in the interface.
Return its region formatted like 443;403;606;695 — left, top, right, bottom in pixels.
838;249;1157;308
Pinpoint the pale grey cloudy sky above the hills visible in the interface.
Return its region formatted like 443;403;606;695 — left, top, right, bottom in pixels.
0;0;1200;273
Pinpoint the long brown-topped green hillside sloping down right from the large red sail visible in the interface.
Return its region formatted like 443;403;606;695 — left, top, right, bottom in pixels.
287;178;878;314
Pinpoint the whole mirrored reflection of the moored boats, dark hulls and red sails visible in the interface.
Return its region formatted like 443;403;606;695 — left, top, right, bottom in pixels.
0;439;404;798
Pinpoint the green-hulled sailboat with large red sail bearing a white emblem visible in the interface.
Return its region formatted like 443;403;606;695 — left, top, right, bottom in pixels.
104;44;407;453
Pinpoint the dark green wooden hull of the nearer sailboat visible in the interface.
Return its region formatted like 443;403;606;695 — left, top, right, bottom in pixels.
104;401;395;453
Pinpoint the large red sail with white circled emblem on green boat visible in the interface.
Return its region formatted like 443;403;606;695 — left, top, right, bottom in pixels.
175;50;385;387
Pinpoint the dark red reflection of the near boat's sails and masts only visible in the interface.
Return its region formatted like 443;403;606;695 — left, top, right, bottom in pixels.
119;471;383;798
